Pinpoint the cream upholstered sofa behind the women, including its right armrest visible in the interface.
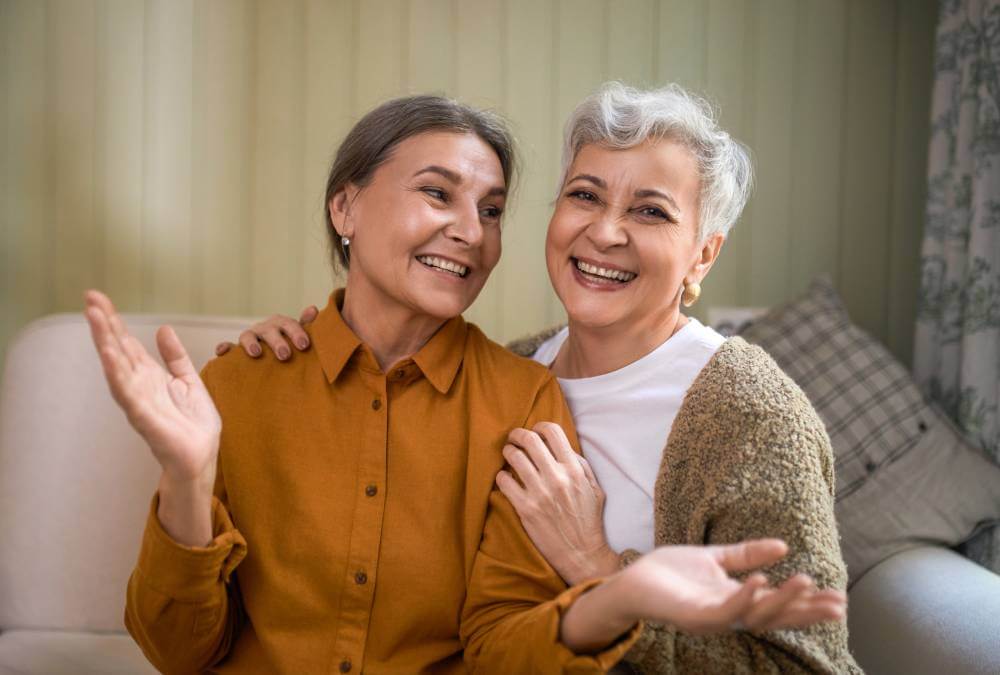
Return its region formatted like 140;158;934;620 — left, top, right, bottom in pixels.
0;315;1000;675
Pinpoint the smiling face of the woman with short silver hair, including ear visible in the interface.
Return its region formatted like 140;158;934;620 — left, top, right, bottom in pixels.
545;139;722;328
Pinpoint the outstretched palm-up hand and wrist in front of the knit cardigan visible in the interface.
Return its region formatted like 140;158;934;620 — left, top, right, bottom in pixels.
561;539;847;651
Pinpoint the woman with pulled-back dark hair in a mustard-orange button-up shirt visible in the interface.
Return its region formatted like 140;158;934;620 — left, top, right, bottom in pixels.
86;92;843;673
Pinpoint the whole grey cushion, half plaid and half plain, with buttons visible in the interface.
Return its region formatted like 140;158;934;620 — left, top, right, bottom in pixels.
742;281;1000;583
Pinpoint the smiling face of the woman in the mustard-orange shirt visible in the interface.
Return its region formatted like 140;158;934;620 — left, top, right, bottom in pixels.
330;132;507;319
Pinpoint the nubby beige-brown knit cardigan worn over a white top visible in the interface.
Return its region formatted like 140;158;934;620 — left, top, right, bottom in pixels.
508;328;861;673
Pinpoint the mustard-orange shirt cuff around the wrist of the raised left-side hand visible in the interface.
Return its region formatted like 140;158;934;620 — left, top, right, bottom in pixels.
137;493;247;602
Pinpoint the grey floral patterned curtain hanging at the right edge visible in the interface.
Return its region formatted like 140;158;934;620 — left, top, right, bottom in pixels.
914;0;1000;569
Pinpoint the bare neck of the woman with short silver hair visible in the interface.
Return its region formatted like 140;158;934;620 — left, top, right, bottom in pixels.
552;306;688;379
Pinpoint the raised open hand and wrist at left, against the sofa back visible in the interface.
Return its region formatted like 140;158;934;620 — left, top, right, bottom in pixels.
84;291;222;546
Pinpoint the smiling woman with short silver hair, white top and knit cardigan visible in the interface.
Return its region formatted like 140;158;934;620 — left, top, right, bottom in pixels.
227;83;860;673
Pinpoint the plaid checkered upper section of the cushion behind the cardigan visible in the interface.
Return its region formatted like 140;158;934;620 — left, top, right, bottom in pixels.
741;280;934;500
